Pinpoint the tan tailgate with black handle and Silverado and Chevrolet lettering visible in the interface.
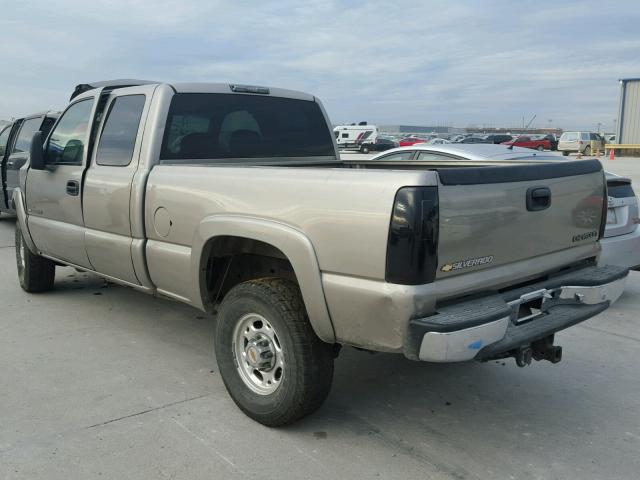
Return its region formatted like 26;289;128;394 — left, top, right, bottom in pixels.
436;160;606;278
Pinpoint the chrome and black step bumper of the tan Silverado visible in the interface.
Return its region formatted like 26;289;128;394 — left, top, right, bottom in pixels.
405;266;628;362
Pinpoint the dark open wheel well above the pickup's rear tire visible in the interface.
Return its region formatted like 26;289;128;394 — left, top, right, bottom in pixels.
200;235;297;311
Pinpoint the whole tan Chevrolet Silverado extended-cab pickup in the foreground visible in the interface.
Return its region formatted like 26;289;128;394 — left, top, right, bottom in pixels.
13;81;627;426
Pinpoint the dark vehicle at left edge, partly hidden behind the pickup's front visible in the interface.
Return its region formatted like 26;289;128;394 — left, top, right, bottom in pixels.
0;112;59;214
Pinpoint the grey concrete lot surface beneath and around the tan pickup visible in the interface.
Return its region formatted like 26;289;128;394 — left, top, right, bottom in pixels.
0;159;640;480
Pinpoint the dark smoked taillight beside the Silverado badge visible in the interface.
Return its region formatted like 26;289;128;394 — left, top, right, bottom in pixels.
385;187;439;285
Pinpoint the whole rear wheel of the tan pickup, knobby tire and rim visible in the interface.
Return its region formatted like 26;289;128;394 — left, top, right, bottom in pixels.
215;278;333;427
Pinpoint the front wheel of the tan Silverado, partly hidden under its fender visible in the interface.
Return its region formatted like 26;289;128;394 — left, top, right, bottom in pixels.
15;222;56;293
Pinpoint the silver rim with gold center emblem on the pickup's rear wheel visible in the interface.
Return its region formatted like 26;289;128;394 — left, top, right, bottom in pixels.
233;313;286;395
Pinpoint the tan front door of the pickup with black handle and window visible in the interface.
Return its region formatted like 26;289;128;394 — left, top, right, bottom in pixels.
25;96;98;268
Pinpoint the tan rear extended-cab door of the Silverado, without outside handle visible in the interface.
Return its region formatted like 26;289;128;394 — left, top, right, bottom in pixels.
83;85;155;285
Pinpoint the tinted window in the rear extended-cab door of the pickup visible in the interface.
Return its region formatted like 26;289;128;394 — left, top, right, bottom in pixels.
96;95;145;167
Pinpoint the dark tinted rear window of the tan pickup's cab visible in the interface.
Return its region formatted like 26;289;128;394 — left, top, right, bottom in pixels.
160;93;335;163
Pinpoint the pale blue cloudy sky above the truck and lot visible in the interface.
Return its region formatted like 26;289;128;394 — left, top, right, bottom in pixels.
0;0;640;130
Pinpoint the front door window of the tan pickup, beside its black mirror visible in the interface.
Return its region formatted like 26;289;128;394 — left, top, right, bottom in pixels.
45;98;93;165
